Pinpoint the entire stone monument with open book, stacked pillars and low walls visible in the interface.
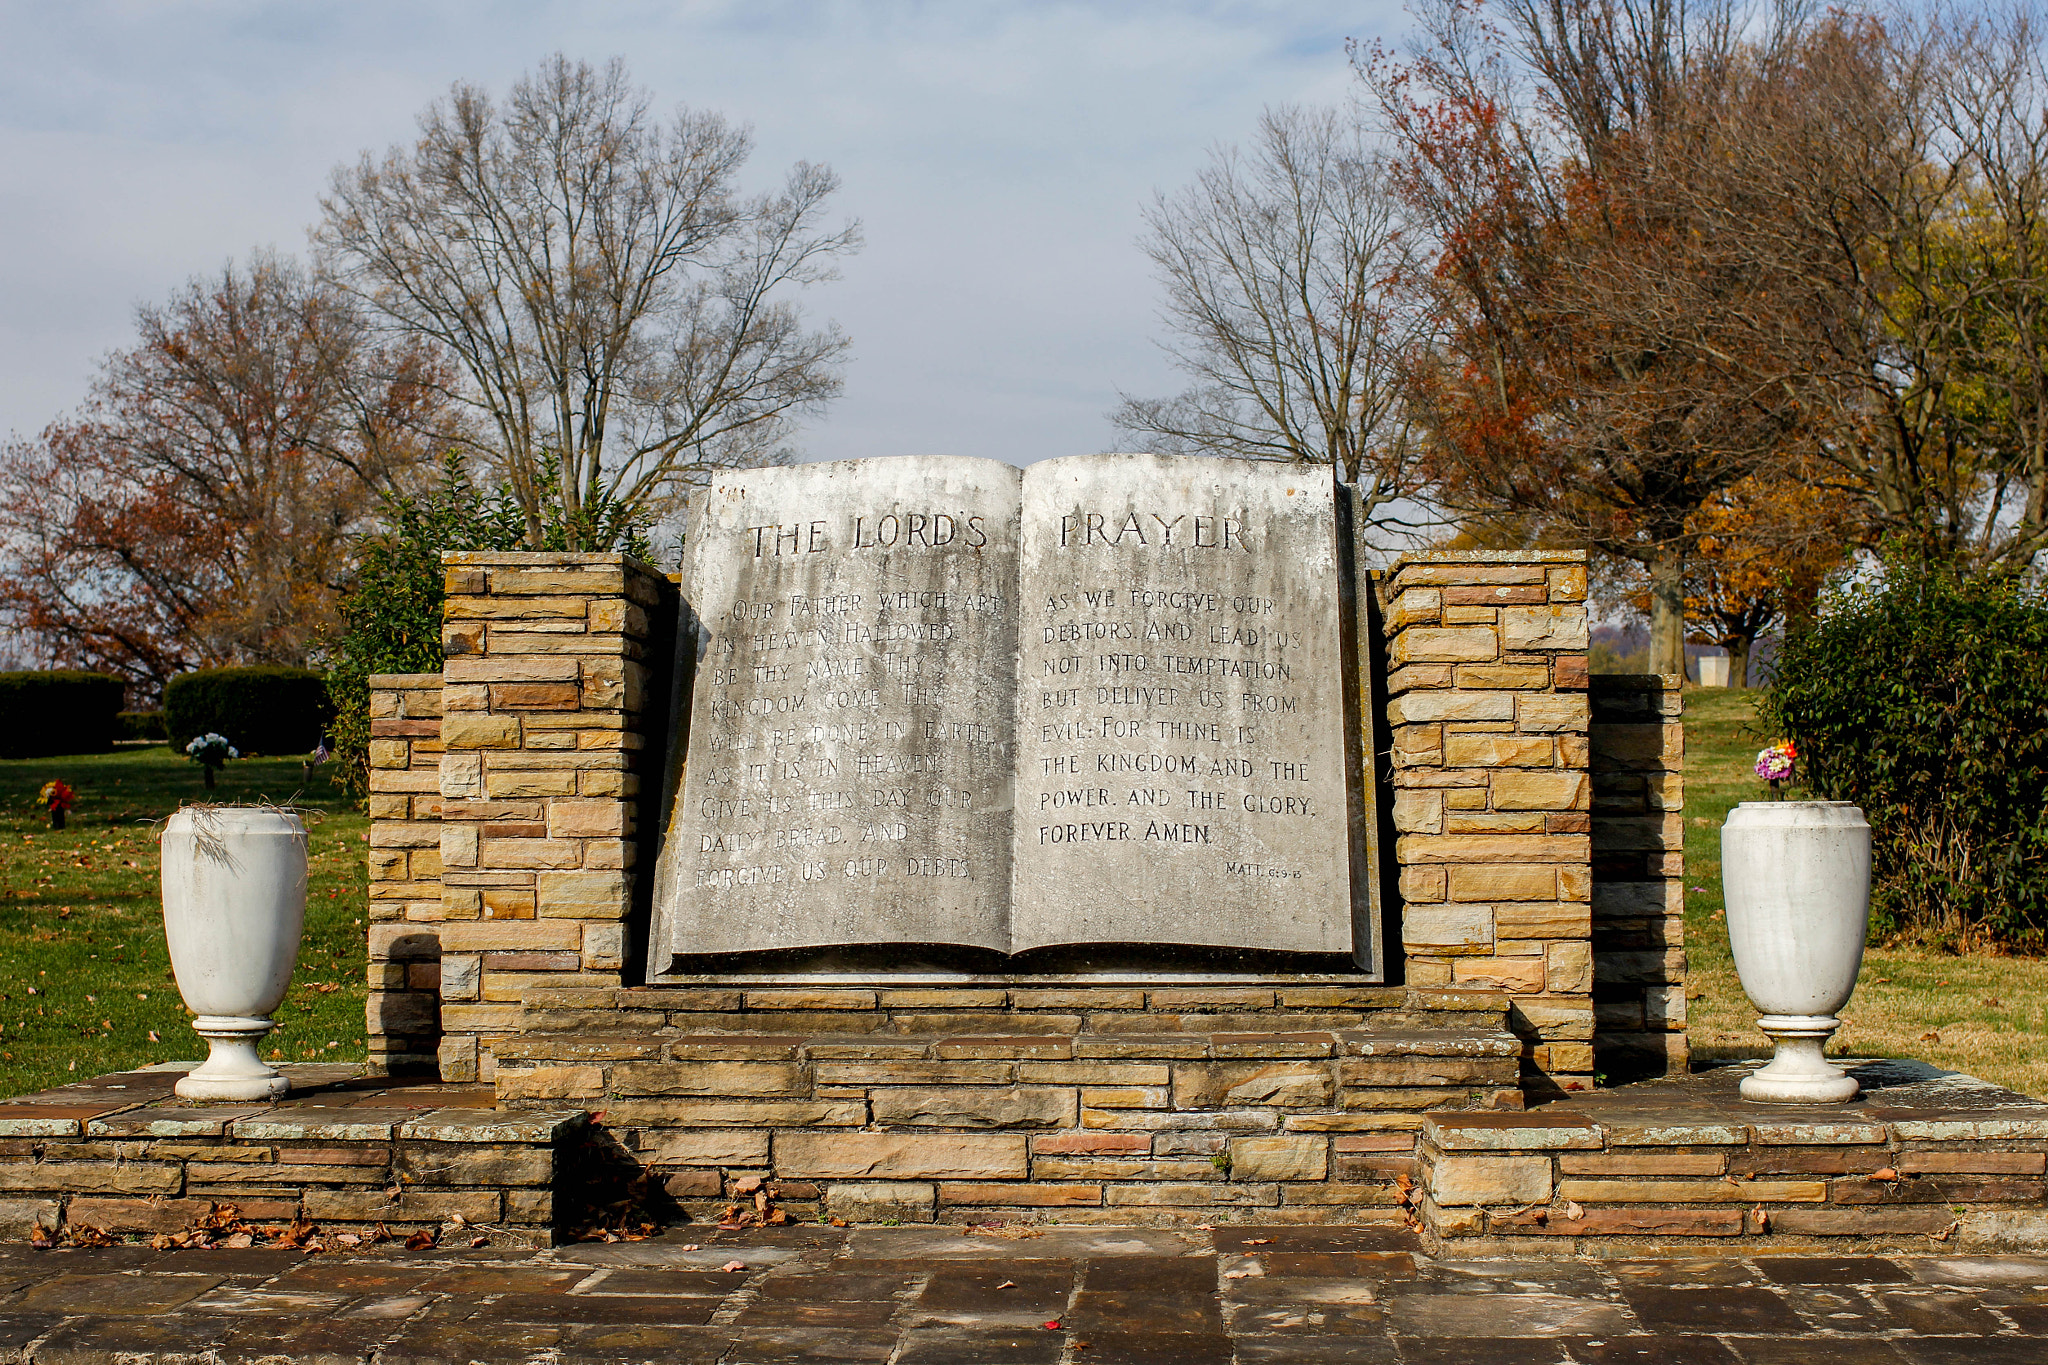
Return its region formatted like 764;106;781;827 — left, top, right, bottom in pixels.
0;456;2048;1260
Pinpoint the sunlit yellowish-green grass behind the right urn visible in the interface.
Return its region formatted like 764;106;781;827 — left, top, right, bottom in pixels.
1686;688;2048;1097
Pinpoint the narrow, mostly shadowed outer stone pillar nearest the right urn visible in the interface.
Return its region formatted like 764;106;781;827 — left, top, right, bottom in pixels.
1591;673;1690;1081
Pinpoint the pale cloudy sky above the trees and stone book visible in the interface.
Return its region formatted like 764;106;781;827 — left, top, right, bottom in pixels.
0;0;1405;465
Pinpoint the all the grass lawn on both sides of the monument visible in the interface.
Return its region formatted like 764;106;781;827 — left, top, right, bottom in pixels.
0;688;2048;1097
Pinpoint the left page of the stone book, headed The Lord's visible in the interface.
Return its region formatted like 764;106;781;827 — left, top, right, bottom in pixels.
655;456;1022;957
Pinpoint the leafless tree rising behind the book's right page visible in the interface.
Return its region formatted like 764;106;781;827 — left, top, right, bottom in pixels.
1112;108;1421;530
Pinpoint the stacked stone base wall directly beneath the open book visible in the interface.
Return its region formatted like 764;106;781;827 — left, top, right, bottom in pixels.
496;982;1522;1224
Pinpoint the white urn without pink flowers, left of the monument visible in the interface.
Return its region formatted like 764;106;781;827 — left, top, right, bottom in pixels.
160;806;305;1101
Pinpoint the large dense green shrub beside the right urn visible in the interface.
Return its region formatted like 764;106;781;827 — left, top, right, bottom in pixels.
1761;563;2048;948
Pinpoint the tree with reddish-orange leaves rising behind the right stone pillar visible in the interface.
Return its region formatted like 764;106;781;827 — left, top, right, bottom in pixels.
1360;0;1851;673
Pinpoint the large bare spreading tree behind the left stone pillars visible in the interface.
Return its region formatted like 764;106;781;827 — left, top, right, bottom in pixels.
315;55;858;546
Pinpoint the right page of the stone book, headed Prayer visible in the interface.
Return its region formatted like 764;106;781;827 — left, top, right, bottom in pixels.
1010;454;1354;954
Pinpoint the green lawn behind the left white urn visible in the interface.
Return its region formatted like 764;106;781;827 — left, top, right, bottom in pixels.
0;745;369;1095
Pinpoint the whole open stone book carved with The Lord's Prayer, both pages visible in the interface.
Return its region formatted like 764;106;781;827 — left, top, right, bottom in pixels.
655;454;1354;964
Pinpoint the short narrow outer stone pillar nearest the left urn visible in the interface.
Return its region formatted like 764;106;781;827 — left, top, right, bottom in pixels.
365;673;440;1074
